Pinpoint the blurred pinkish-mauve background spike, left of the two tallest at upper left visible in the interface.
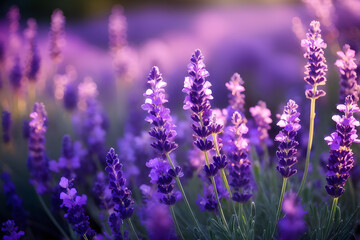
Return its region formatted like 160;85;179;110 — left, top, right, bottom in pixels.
50;9;65;64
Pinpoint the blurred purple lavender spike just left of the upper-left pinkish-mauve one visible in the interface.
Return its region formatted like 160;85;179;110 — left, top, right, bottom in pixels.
25;19;40;81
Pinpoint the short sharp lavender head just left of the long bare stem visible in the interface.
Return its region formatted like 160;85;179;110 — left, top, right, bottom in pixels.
275;99;301;178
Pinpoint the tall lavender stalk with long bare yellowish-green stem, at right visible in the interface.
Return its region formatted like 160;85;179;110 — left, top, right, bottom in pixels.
298;21;327;194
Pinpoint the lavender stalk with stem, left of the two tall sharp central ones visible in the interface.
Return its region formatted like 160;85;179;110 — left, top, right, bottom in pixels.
141;67;205;236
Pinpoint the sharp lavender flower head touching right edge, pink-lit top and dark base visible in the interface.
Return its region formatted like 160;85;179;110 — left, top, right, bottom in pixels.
325;95;360;198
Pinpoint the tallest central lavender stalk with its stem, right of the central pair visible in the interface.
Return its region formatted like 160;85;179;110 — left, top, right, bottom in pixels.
183;49;228;228
